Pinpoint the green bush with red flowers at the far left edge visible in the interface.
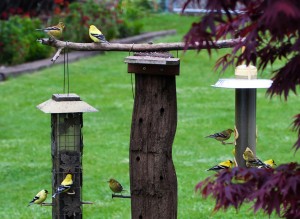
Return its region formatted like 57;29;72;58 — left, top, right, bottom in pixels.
0;16;52;64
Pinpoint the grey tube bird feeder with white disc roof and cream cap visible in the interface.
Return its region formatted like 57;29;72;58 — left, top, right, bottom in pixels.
212;65;272;167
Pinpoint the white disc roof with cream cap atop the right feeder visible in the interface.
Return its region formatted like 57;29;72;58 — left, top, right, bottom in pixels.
212;65;273;89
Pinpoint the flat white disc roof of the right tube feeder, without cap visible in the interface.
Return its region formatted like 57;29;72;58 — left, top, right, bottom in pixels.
211;78;273;89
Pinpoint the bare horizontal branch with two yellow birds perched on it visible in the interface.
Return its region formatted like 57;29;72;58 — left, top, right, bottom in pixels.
38;38;243;52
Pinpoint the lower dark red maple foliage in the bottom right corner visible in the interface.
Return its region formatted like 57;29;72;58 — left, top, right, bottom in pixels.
196;163;300;219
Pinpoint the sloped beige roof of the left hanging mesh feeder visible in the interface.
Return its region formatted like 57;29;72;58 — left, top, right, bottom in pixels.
37;94;98;113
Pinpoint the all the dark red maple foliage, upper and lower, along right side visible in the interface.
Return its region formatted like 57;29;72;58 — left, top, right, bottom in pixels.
183;0;300;219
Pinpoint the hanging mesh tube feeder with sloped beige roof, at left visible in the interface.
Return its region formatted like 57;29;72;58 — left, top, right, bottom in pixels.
37;94;97;219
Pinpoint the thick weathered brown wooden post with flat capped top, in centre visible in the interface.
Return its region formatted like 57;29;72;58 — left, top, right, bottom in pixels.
125;53;180;219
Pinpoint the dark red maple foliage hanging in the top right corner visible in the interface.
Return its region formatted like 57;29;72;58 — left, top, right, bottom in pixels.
183;0;300;150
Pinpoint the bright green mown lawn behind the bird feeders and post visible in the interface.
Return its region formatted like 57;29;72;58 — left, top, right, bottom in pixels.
0;14;300;219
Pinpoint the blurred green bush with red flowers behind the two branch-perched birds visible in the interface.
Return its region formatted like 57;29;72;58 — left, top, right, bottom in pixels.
52;0;146;42
